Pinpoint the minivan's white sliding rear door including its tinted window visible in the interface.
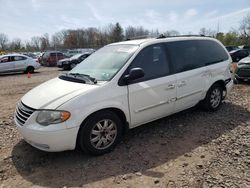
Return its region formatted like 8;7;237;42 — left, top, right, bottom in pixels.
166;40;208;112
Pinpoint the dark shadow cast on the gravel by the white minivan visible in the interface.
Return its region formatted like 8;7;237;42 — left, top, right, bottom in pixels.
12;103;250;187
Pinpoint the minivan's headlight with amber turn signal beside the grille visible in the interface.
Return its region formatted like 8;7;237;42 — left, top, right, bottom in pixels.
36;110;70;126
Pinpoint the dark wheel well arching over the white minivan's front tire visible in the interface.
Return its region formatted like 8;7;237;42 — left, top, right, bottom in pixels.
76;108;129;148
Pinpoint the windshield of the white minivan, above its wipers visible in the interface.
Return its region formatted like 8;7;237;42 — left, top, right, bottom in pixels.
70;44;139;81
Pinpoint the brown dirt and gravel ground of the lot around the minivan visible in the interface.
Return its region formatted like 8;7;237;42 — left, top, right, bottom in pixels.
0;68;250;188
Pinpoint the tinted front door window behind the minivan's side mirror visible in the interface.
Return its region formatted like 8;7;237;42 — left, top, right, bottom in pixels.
128;44;170;82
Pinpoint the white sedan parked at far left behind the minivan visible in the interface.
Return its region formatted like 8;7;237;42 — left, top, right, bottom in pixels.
0;54;40;73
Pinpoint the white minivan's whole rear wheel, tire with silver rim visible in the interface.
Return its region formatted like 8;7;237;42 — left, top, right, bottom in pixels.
202;84;223;112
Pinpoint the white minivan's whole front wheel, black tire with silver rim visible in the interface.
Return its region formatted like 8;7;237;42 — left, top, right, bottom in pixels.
78;110;122;155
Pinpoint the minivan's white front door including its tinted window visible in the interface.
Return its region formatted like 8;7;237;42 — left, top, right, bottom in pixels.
127;44;176;127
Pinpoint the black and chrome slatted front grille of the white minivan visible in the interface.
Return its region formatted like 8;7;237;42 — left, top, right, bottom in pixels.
15;102;35;126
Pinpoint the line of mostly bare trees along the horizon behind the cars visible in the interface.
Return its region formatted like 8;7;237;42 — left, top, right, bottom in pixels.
0;14;250;52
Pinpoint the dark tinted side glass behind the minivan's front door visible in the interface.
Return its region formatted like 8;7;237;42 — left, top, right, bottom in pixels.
166;40;228;73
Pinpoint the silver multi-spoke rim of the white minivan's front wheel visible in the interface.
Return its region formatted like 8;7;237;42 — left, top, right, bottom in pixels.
90;119;117;149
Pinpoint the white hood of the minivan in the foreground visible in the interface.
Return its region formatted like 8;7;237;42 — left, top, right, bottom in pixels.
21;78;100;109
